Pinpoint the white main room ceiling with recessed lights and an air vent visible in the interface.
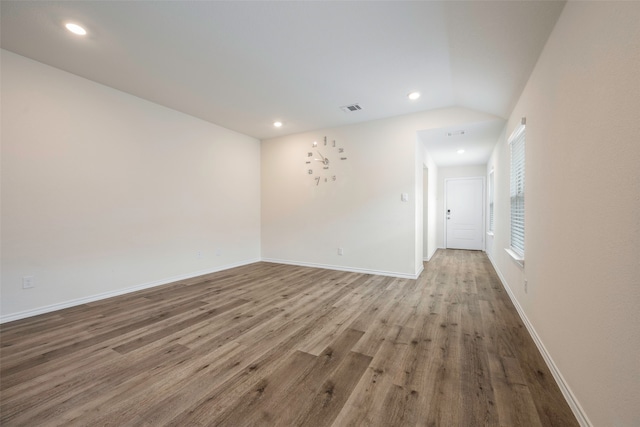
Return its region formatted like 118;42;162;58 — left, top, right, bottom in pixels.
0;0;564;162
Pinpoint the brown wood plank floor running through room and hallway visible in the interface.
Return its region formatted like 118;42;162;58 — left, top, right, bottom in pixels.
0;250;578;427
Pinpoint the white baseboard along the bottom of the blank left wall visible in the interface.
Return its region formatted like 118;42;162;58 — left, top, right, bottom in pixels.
0;258;260;324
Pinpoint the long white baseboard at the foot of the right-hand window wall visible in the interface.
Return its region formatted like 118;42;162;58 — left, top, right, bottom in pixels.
487;253;593;427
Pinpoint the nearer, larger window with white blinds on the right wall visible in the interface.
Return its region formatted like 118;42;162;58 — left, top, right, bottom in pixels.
509;118;525;260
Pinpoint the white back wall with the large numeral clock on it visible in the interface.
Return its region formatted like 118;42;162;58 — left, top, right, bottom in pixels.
262;108;493;277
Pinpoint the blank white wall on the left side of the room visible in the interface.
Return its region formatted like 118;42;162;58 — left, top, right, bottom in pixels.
1;51;260;320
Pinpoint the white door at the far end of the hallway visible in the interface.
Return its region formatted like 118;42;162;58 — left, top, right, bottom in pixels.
445;177;484;250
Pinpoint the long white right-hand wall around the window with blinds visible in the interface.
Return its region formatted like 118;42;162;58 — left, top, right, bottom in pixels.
485;2;640;426
